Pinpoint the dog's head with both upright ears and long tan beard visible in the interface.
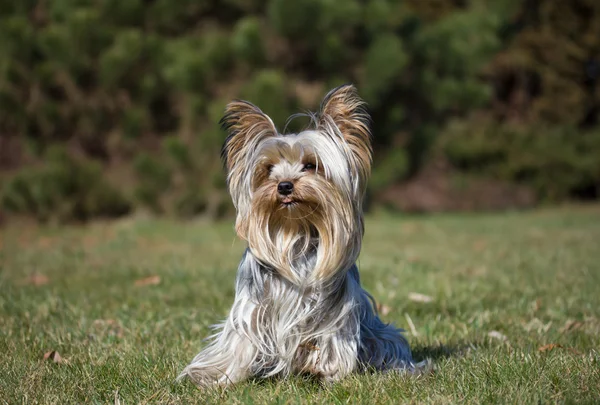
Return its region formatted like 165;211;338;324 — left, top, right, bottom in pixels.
222;85;372;282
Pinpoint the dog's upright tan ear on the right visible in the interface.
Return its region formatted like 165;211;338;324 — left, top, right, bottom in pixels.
318;84;372;181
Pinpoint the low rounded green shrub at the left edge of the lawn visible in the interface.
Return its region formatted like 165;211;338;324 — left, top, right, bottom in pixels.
1;148;131;222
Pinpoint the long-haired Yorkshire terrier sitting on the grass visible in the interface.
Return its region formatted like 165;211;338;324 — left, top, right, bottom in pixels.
179;85;415;386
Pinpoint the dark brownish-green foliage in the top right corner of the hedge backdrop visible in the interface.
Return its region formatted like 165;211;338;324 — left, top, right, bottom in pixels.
490;0;600;126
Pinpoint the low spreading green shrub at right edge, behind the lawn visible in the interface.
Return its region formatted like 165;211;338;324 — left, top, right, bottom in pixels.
440;120;600;200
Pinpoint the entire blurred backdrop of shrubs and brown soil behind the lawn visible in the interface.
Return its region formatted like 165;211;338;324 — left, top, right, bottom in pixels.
0;0;600;223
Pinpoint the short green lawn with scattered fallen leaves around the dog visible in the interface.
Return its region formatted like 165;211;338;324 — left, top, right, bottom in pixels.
0;206;600;404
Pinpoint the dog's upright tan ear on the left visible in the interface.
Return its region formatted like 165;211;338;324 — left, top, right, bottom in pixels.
221;100;277;171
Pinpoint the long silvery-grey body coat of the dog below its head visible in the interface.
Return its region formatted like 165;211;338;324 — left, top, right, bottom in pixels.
180;250;414;386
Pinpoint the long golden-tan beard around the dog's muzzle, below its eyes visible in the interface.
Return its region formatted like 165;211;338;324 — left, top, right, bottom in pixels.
237;176;363;286
